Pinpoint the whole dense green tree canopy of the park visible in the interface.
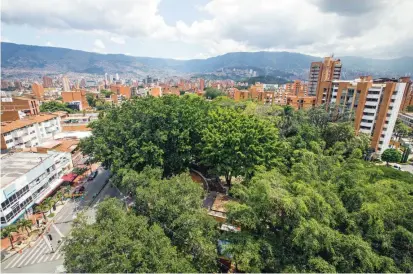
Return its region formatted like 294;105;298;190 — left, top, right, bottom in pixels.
71;95;413;272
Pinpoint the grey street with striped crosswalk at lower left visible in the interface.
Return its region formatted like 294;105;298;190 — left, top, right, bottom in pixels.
1;169;120;273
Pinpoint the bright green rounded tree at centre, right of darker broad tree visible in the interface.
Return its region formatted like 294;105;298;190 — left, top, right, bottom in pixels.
201;108;279;186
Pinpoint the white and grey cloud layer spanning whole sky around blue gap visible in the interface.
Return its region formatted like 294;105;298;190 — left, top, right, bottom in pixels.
1;0;413;57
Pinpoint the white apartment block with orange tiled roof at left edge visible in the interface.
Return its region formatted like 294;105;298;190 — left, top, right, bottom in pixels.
1;114;62;150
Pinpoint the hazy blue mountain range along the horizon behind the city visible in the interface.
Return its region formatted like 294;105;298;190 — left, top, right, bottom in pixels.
1;42;413;79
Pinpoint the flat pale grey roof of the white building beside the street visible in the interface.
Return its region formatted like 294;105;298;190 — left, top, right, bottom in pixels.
0;152;52;189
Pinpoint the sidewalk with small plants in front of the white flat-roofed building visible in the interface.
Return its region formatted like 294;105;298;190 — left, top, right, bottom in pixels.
1;199;69;262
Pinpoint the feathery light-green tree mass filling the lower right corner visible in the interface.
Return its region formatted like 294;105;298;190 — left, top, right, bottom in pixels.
226;156;413;272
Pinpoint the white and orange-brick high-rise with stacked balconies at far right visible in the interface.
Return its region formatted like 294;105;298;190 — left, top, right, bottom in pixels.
317;76;408;154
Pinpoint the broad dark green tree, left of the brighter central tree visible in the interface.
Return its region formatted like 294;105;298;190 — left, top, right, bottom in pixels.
80;95;211;176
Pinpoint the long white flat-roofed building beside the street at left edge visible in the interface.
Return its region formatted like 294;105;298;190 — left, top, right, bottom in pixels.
0;151;72;227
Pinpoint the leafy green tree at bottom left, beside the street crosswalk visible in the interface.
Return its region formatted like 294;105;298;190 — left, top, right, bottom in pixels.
62;199;195;273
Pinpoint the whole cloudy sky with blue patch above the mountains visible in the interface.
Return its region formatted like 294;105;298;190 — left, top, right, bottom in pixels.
1;0;413;59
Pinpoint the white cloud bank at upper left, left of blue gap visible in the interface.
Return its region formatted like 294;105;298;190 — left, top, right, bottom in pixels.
1;0;173;37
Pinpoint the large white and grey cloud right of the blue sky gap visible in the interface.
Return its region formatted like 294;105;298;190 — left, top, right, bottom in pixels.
176;0;413;57
